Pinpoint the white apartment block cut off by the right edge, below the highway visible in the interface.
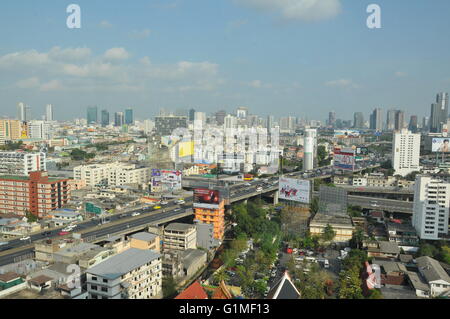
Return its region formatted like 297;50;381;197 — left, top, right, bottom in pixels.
412;176;450;240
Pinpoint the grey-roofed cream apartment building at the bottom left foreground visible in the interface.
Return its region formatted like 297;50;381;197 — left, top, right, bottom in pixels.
86;248;162;299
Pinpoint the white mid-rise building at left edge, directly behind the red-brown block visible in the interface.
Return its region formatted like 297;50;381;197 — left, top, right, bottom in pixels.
0;152;47;176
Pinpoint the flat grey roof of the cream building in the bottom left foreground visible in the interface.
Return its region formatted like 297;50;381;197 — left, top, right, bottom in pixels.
86;248;161;279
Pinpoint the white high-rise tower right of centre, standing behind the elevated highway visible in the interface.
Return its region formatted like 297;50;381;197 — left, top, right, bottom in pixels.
392;129;420;176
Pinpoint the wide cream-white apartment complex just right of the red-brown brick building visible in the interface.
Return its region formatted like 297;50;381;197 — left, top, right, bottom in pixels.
73;162;150;186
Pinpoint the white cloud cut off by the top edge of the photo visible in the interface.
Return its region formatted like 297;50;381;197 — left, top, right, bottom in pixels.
234;0;342;21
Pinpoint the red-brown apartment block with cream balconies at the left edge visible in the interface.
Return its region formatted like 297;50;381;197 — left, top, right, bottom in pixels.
0;171;70;217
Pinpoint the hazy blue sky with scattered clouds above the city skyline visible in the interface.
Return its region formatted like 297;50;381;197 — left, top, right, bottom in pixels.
0;0;450;120
